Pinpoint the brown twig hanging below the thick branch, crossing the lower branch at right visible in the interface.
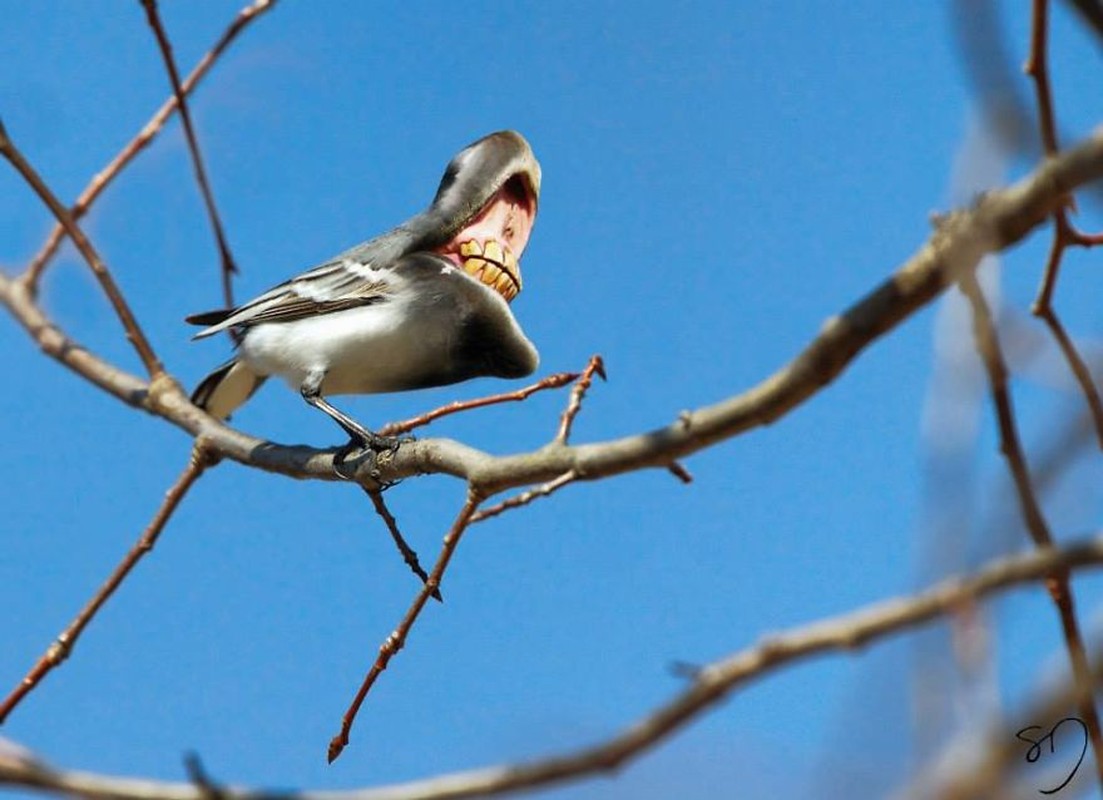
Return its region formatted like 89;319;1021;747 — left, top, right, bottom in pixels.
960;273;1103;785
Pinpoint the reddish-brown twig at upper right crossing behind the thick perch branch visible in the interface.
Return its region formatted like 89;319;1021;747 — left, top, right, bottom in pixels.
1025;0;1103;449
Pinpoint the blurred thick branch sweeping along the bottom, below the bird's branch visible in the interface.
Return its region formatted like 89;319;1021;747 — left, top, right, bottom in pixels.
0;529;1103;800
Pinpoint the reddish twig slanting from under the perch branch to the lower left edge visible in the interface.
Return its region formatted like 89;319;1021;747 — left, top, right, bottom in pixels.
0;447;211;724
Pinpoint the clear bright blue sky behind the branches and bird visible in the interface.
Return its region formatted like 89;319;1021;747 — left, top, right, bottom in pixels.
0;0;1101;799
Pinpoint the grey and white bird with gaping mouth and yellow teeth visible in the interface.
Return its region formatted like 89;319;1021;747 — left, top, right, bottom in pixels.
188;130;540;447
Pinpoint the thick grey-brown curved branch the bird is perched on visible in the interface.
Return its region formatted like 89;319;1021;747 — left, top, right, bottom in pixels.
0;131;1103;497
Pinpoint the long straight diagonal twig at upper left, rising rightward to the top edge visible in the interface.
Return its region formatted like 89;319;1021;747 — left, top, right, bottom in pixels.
23;0;277;295
